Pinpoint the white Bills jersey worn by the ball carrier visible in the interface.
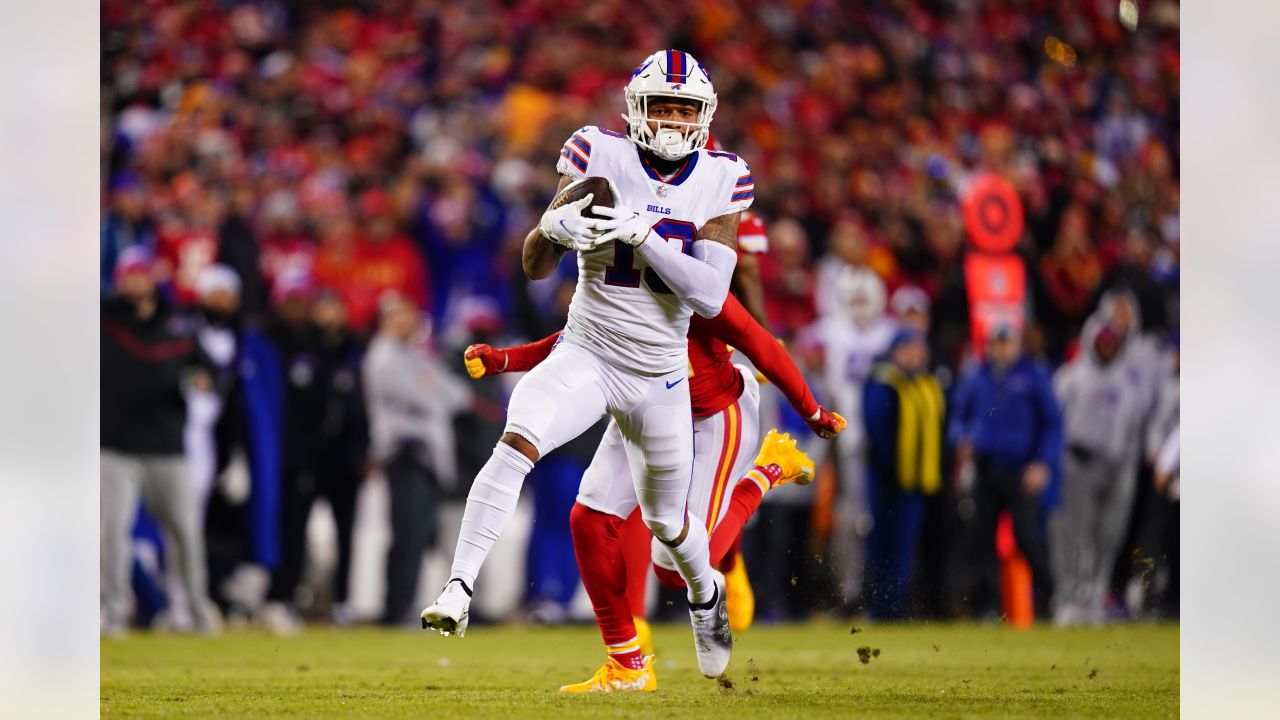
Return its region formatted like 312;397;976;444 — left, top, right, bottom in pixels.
556;126;755;375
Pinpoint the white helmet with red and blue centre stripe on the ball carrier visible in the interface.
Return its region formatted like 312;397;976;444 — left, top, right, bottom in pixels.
622;50;716;160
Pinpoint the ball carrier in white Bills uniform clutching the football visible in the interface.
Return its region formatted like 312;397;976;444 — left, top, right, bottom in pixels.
422;50;754;678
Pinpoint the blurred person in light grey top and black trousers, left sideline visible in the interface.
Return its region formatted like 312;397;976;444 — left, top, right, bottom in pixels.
362;292;471;625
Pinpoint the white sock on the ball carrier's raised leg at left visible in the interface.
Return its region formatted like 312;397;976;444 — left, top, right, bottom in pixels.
449;442;534;588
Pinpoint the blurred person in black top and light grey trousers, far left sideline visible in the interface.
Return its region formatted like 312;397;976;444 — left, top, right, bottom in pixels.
100;246;219;635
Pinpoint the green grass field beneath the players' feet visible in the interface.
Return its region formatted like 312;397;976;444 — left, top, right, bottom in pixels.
101;623;1179;720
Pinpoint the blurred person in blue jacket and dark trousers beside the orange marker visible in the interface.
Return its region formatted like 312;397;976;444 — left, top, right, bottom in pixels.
948;324;1062;618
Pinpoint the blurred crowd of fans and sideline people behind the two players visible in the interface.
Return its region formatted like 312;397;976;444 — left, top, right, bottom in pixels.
101;0;1180;629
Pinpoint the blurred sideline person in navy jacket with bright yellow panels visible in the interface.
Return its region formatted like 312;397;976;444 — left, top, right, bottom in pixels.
863;328;946;620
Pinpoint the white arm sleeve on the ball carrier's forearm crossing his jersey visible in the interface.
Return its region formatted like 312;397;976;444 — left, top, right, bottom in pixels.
636;232;737;318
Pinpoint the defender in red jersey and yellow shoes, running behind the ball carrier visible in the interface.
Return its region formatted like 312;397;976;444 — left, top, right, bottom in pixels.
463;288;845;692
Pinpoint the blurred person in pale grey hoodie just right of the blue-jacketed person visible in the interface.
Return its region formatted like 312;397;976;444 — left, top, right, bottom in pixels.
1050;302;1155;625
